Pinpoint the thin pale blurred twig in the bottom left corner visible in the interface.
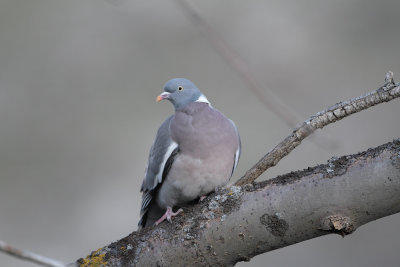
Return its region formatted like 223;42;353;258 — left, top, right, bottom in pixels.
0;240;66;267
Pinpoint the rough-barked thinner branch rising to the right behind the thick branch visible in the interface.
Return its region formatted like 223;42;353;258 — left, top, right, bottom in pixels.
235;71;400;185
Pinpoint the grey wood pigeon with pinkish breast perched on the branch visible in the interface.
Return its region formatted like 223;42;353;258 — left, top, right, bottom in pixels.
139;78;241;229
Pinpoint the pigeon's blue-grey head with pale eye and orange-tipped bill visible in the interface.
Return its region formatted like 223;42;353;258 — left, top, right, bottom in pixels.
157;78;209;109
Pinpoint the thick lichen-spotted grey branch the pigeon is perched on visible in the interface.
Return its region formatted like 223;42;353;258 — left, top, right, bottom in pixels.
78;139;400;266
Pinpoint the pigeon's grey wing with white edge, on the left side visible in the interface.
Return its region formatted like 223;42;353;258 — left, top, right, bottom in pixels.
139;116;178;225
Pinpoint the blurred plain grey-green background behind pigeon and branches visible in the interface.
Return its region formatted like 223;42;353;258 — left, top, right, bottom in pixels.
0;0;400;267
